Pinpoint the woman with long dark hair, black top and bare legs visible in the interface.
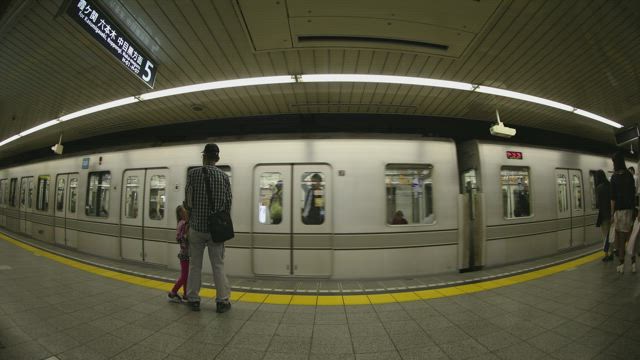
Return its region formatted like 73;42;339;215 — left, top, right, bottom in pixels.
611;151;636;273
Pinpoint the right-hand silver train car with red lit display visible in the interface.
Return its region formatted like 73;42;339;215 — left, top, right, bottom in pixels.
458;141;624;268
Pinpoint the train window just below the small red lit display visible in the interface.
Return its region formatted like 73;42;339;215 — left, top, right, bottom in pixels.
500;166;531;219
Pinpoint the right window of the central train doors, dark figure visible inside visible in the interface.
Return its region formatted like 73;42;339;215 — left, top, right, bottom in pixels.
300;172;325;225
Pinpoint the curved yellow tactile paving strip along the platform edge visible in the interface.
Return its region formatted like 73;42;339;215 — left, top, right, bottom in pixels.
0;233;601;306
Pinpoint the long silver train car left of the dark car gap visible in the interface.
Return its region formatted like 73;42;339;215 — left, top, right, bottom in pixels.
0;138;460;279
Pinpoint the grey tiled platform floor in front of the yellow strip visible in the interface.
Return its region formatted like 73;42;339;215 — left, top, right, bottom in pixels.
0;235;640;359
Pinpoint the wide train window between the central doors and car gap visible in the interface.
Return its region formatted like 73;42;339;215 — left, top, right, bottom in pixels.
385;164;435;225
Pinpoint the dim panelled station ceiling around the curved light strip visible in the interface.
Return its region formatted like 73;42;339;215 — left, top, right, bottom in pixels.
0;0;640;159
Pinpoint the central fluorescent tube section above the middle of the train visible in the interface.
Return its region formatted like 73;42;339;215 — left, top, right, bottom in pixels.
300;74;474;91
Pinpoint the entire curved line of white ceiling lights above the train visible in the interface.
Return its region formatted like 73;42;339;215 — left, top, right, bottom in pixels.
0;74;622;146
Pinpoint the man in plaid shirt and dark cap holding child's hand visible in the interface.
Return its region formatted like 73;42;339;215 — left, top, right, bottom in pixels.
185;144;231;313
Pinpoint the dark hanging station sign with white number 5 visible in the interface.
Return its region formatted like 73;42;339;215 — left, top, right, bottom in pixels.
67;0;158;89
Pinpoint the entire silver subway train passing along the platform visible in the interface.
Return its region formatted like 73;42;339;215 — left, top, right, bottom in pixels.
0;136;624;279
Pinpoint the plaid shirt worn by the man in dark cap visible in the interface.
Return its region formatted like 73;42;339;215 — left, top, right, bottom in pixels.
184;165;231;232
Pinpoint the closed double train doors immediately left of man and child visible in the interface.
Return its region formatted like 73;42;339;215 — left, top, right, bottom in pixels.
120;169;168;264
